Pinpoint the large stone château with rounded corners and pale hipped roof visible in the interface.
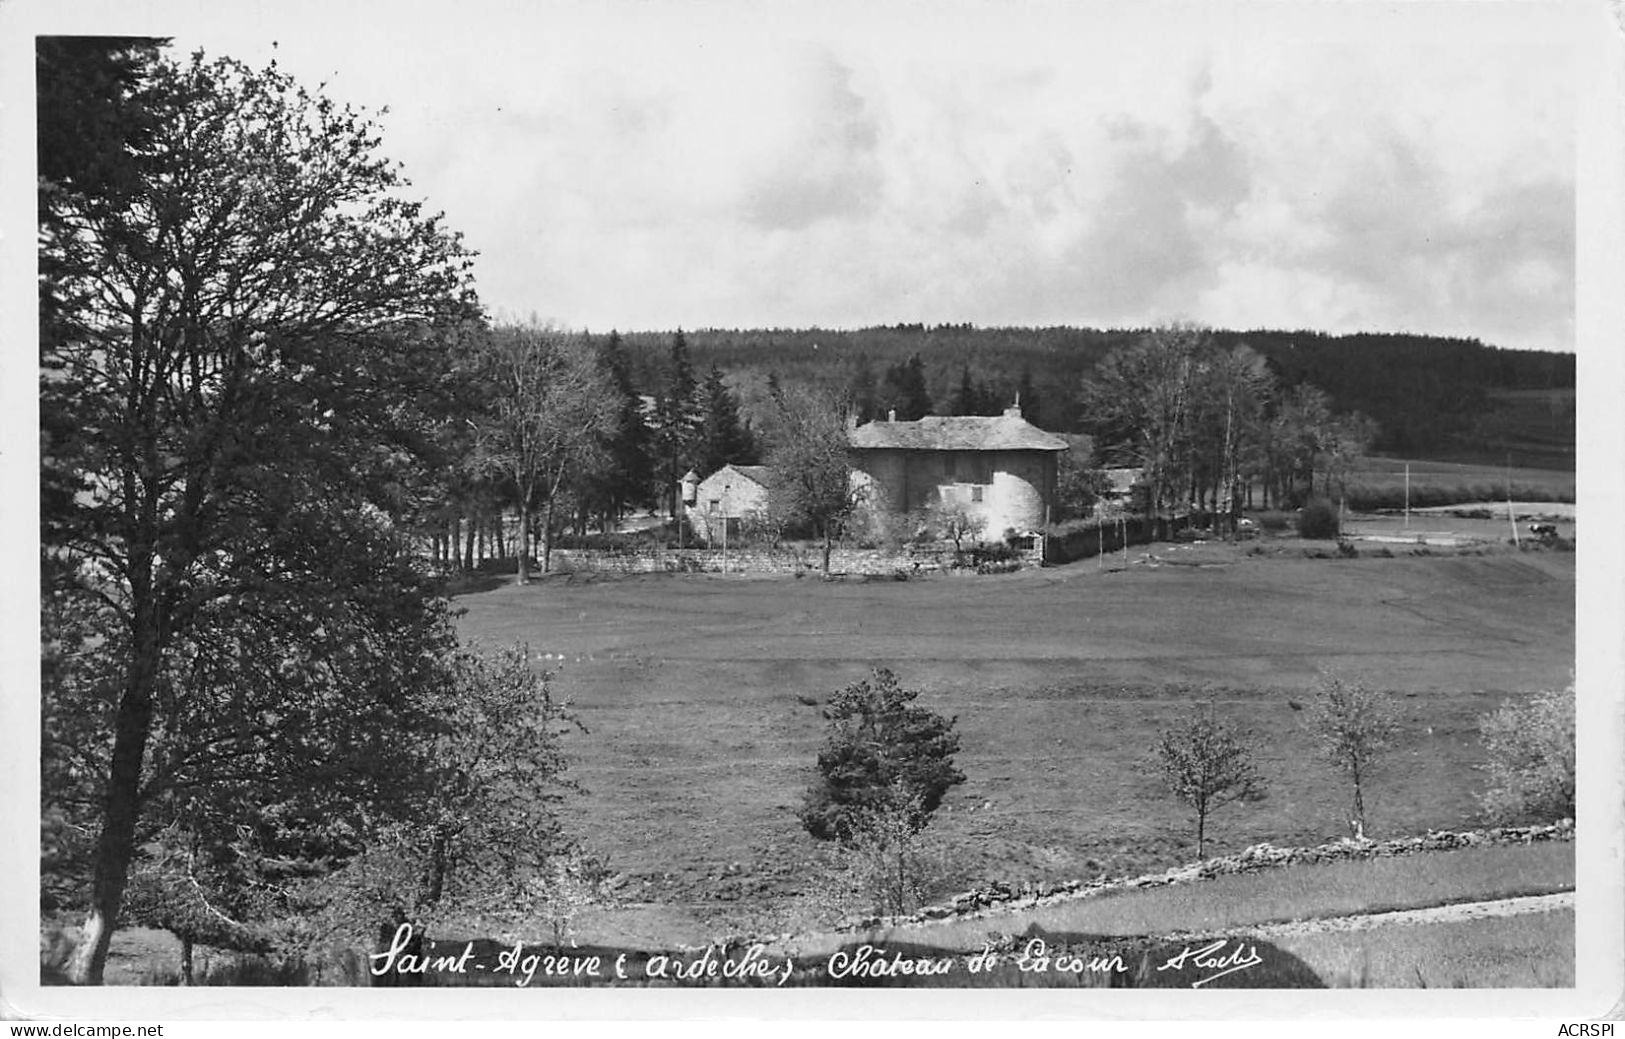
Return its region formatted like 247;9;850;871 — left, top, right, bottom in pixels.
848;403;1069;540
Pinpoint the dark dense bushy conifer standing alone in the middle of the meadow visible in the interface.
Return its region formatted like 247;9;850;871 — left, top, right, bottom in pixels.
801;667;965;844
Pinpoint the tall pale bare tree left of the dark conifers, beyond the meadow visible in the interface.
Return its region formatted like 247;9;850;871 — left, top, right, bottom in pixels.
473;327;621;584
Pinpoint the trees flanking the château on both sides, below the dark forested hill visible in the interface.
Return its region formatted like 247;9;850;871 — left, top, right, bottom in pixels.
449;327;1375;580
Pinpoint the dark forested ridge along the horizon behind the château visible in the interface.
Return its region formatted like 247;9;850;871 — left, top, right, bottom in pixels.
604;324;1575;454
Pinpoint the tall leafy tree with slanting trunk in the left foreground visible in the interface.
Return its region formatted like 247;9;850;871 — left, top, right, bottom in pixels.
41;46;475;982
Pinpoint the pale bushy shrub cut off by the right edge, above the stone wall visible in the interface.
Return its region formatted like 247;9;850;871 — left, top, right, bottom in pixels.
1479;683;1575;823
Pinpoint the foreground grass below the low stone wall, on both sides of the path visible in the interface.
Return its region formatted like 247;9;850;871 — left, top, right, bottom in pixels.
88;842;1575;989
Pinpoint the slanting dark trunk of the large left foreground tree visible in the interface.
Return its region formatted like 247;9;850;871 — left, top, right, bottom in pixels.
68;591;163;985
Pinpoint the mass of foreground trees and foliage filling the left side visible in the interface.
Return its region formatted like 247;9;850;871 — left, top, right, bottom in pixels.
37;37;614;984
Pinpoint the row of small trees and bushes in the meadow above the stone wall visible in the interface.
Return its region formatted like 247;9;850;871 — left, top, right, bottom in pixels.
800;668;1575;915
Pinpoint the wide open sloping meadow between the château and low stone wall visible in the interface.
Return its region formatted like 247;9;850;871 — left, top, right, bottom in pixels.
458;533;1575;943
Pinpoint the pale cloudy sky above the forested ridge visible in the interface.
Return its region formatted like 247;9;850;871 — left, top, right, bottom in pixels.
41;0;1576;350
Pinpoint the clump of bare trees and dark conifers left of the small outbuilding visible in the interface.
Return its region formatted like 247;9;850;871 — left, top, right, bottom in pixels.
429;327;773;582
